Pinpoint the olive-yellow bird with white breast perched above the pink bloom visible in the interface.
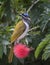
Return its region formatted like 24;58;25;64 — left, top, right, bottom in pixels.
8;13;31;63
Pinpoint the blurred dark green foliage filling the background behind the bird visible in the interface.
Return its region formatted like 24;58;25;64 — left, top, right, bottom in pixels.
0;0;50;65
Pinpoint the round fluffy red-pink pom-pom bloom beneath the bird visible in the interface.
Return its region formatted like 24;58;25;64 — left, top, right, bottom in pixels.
13;43;30;59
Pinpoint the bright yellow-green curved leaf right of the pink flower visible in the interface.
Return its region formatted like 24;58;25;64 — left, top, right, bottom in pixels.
35;34;50;59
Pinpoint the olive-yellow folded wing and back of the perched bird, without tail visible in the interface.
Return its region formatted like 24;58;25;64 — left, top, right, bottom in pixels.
11;20;26;43
